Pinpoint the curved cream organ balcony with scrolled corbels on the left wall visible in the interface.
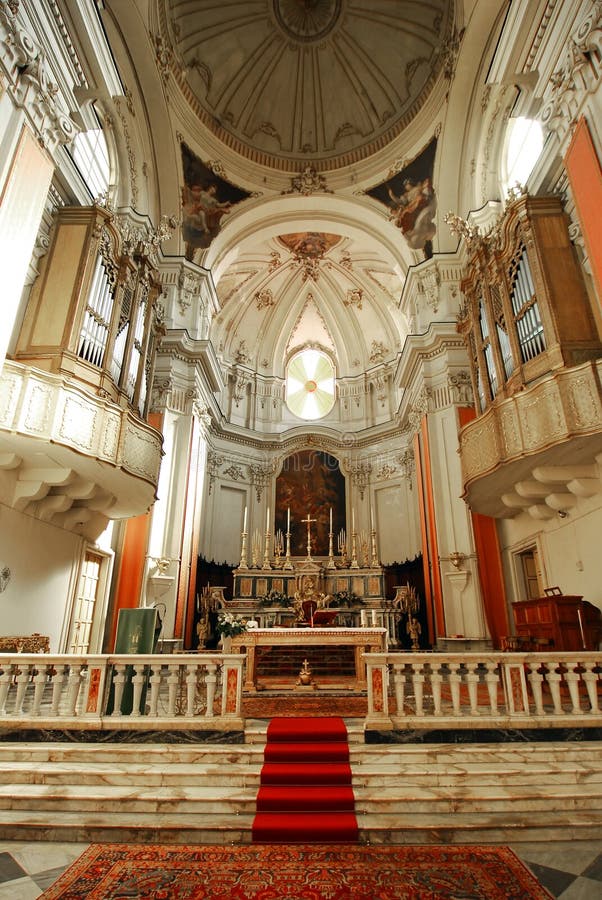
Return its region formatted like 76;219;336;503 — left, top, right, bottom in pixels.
0;360;162;540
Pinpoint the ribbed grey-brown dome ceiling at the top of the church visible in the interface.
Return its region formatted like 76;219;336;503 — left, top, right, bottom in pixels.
167;0;453;169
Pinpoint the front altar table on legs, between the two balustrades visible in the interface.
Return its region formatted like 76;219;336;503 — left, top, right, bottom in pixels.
232;628;387;692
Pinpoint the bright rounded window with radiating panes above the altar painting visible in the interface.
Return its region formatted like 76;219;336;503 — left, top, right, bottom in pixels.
286;347;335;419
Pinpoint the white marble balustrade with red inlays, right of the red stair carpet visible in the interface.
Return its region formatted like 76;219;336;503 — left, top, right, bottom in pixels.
364;651;602;730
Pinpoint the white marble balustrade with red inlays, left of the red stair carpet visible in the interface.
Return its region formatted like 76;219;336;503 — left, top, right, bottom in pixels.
0;653;244;731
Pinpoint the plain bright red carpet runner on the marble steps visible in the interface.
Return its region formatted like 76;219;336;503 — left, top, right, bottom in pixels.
253;717;358;844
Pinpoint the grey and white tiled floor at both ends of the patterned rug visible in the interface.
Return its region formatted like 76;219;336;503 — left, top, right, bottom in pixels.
0;840;602;900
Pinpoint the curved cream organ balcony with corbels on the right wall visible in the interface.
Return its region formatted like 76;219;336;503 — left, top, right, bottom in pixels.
460;359;602;519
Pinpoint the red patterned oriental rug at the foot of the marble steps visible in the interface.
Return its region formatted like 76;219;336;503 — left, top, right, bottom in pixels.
42;844;551;900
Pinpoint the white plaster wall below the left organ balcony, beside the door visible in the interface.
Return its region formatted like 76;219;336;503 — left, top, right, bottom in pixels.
0;506;83;653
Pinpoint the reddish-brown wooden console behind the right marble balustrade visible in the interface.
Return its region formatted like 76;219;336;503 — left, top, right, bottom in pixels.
512;588;602;650
